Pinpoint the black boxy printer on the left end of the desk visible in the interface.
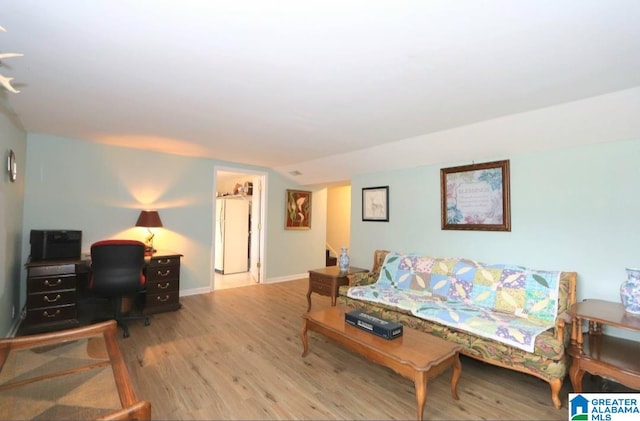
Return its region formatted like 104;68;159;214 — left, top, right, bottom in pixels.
29;230;82;261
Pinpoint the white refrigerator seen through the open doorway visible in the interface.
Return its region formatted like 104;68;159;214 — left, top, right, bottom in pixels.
215;197;251;275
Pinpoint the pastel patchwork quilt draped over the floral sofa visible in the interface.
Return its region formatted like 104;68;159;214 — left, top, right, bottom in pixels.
347;253;561;352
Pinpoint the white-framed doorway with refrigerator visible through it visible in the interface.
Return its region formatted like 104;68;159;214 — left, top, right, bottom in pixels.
210;167;267;290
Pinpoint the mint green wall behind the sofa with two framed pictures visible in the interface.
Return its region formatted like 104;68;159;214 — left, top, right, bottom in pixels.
351;140;640;301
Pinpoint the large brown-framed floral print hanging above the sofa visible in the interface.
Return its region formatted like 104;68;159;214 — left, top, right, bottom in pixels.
440;160;511;231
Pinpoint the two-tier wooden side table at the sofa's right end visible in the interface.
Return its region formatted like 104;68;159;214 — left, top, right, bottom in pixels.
569;300;640;393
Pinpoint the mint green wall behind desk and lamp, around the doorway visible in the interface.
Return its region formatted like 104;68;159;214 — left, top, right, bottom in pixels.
21;134;326;312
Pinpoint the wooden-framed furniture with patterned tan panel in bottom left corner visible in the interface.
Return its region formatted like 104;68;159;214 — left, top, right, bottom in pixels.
0;321;151;420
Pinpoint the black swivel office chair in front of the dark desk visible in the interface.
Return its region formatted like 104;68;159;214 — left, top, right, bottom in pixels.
89;240;150;338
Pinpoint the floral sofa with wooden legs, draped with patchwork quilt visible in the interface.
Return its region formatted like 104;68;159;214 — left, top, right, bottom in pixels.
338;250;577;409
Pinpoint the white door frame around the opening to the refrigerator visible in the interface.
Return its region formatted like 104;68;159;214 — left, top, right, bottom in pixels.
209;165;268;291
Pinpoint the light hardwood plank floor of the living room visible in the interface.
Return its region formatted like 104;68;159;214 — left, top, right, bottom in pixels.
119;279;632;420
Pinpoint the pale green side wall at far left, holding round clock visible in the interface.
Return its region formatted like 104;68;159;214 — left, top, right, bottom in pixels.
0;97;27;336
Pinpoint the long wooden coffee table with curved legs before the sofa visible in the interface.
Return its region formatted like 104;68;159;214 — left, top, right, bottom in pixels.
301;307;462;420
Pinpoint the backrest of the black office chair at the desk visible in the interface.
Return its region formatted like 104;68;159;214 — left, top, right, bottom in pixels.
89;240;145;296
